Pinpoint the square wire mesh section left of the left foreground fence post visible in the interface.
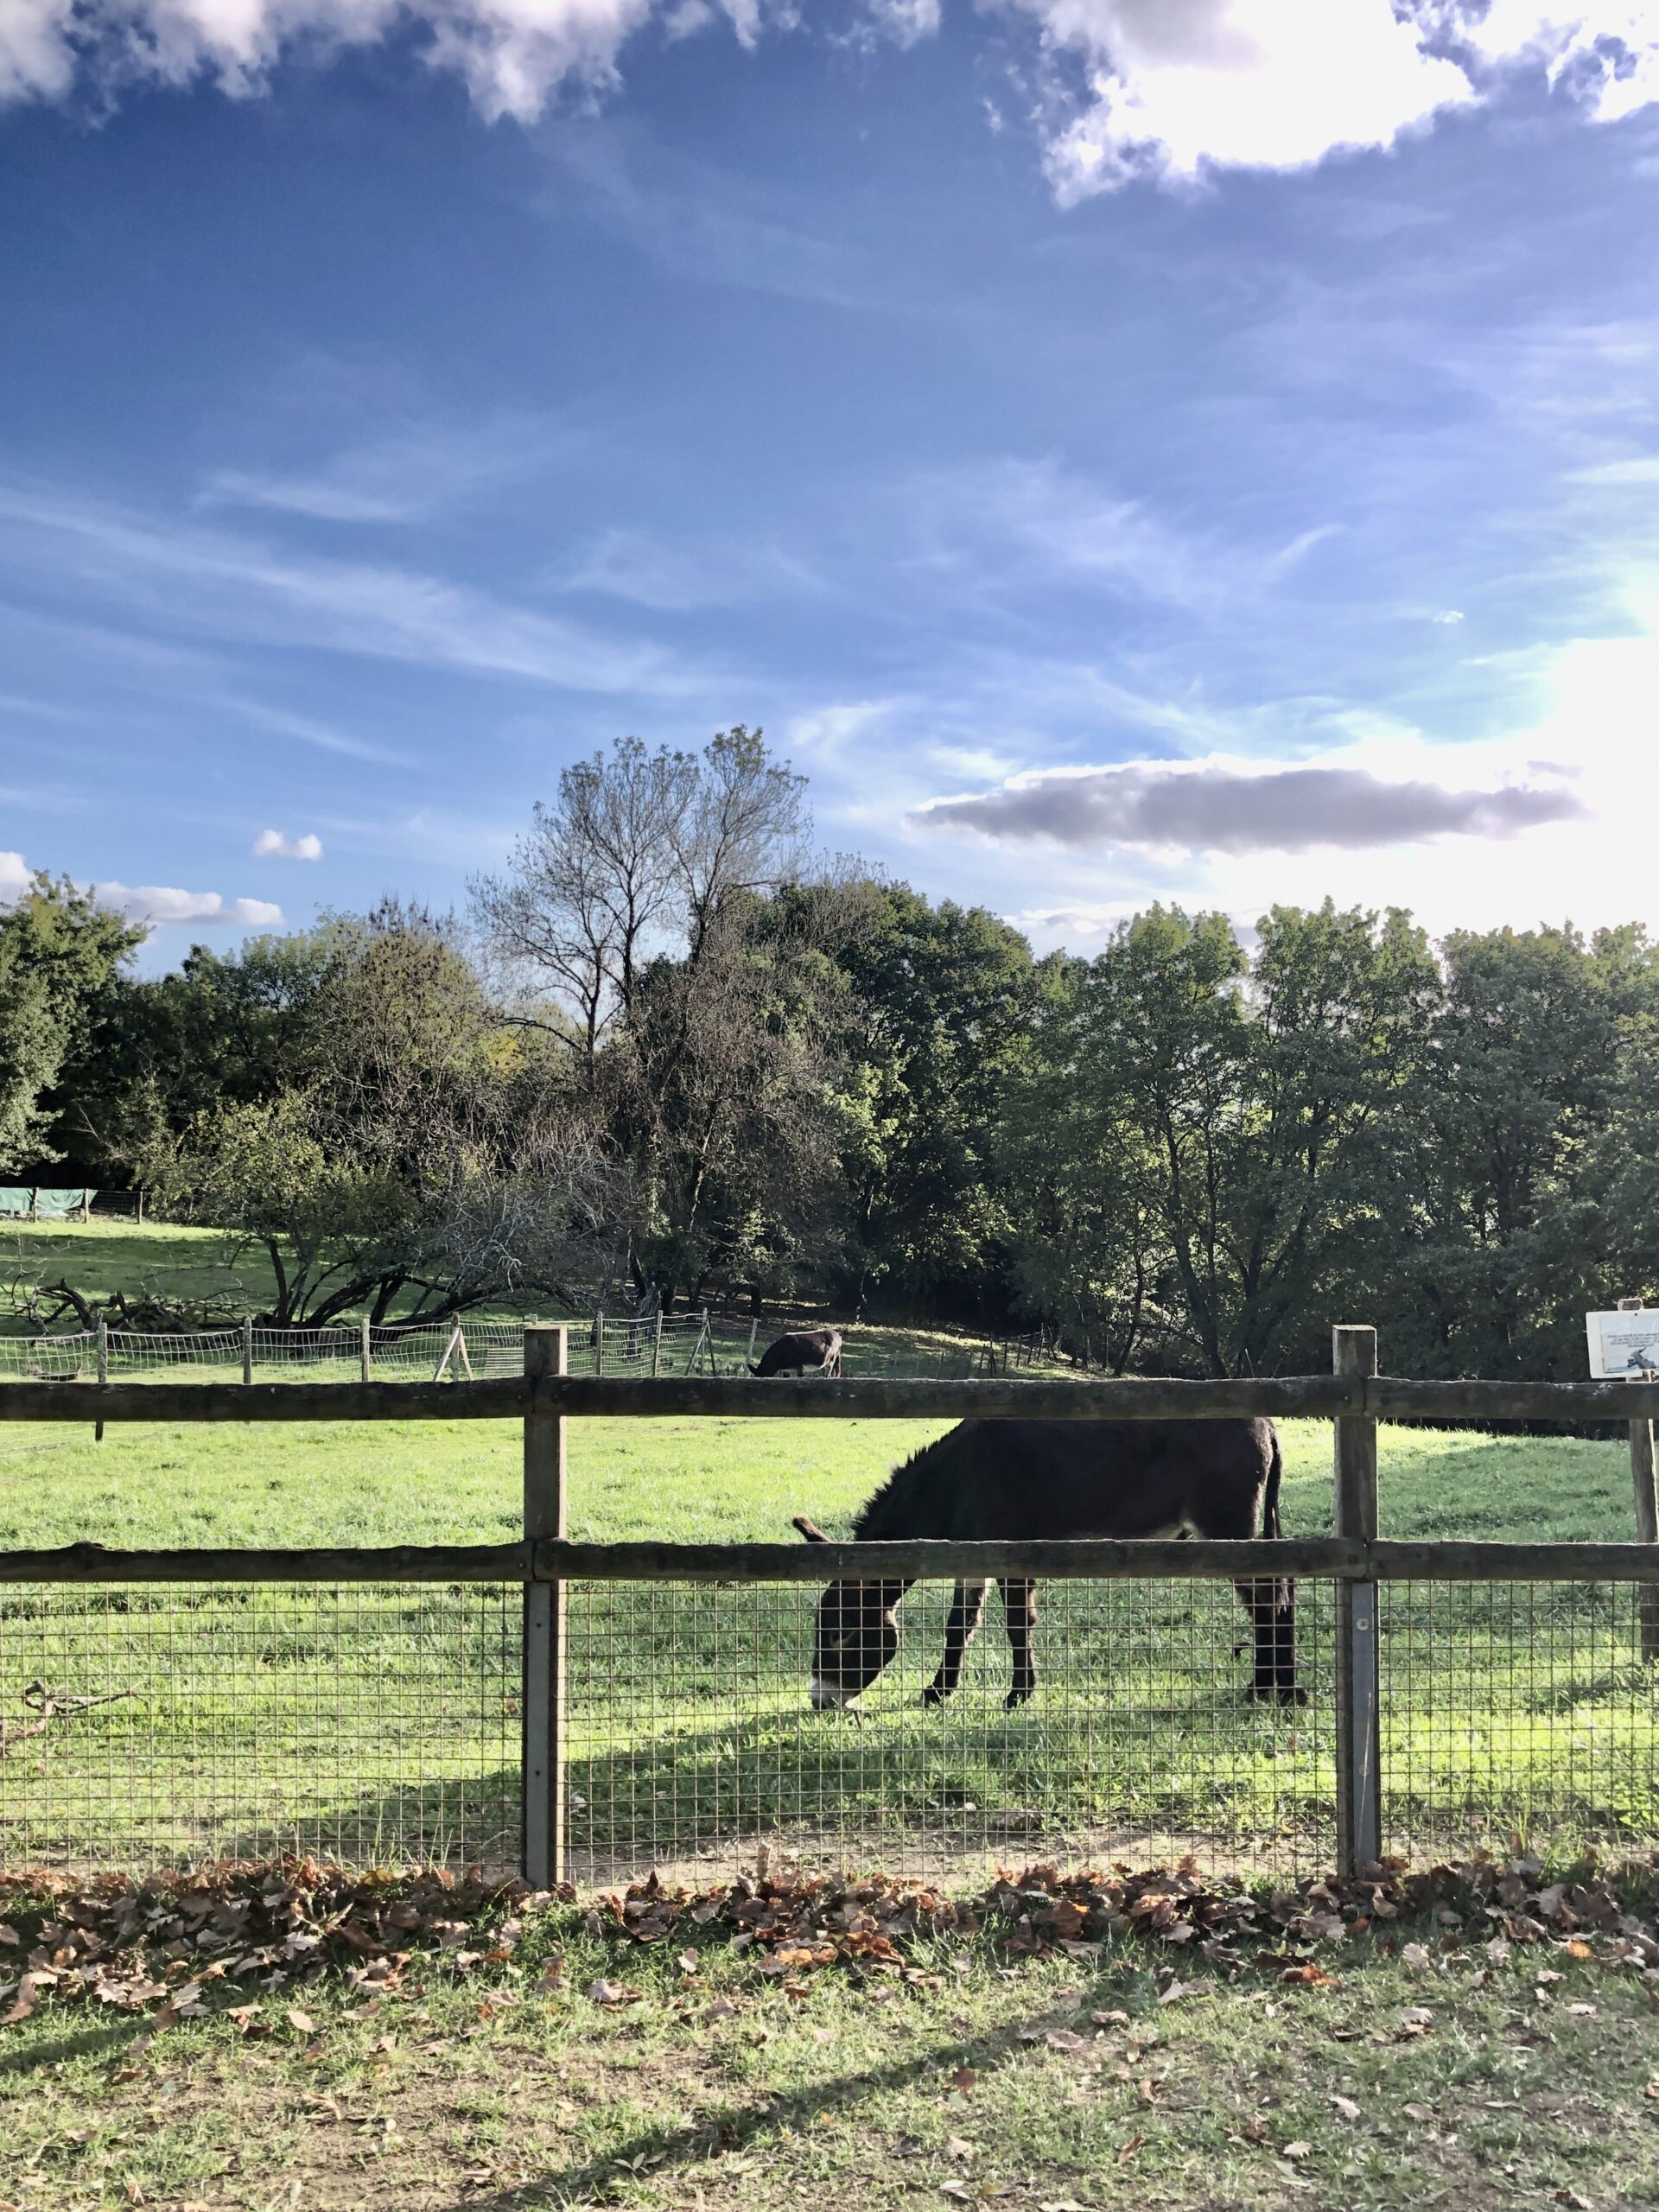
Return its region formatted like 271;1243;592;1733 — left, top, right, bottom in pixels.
0;1584;522;1869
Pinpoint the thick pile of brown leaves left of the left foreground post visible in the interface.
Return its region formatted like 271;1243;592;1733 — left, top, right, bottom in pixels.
0;1858;550;2026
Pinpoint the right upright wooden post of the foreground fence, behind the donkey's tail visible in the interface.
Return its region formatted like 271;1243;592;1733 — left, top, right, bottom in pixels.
1332;1327;1382;1876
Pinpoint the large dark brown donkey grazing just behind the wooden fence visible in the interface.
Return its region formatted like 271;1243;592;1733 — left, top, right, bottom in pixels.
794;1421;1305;1710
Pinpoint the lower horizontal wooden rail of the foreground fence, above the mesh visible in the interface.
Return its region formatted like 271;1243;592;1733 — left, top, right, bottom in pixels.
0;1537;1659;1586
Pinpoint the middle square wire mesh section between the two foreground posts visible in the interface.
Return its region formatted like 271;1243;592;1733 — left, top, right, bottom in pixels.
566;1580;1334;1883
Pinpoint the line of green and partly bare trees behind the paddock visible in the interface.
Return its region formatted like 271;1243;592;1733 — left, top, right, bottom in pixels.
0;728;1659;1376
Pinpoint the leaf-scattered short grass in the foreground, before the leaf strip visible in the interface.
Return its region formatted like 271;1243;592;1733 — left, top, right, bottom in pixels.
0;1875;1659;2212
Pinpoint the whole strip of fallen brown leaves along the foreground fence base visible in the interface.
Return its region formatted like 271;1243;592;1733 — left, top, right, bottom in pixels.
0;1853;1659;2033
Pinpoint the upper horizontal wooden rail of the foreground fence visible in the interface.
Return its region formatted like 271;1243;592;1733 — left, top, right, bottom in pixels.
0;1376;1659;1425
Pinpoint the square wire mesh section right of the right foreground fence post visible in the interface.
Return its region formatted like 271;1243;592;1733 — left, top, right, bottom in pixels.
1378;1581;1659;1858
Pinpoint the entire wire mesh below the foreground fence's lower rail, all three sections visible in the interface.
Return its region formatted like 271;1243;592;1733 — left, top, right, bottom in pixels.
0;1577;1659;1885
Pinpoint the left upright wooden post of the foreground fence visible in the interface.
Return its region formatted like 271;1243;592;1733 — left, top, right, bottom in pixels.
522;1320;566;1889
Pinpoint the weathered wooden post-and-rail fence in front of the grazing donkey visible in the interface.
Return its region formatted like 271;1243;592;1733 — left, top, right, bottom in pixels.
0;1323;1659;1887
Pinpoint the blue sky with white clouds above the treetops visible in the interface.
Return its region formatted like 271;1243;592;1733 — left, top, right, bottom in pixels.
0;0;1659;963
